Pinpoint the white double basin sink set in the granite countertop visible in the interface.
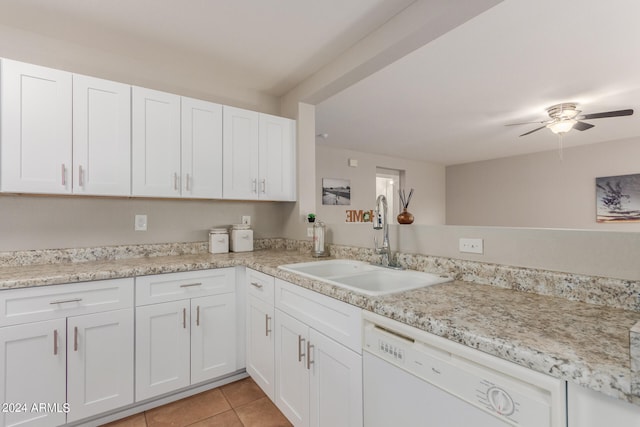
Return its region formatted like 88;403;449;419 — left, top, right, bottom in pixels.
278;259;452;296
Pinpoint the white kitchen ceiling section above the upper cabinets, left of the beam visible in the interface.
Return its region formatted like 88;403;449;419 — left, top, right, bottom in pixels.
0;0;414;96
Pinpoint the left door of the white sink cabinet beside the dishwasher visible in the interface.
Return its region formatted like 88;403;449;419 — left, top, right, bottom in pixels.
275;310;310;427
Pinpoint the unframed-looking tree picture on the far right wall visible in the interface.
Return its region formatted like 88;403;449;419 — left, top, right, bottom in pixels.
596;173;640;222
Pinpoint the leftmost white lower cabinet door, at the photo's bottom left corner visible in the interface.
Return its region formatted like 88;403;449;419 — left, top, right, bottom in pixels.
0;319;66;427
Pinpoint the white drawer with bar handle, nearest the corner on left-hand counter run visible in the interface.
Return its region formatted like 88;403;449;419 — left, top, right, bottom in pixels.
136;267;236;306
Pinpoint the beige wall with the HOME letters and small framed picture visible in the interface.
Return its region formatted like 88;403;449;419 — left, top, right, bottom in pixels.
315;142;445;225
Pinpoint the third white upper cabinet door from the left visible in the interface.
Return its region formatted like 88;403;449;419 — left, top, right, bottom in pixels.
131;86;180;197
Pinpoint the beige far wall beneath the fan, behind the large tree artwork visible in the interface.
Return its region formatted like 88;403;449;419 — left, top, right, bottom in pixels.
446;139;640;231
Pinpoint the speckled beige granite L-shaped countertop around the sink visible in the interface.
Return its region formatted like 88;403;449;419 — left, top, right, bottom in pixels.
0;250;640;405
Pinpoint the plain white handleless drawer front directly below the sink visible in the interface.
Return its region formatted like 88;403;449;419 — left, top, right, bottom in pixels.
275;279;362;353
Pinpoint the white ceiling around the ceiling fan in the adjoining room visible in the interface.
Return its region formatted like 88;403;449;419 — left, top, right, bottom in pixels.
316;0;640;165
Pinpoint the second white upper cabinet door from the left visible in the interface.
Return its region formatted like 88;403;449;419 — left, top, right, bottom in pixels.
72;74;131;196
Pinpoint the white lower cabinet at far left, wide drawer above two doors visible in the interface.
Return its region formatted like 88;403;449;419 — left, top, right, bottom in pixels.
0;279;133;427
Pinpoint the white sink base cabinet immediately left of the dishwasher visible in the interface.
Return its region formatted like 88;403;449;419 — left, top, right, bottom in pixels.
274;279;363;427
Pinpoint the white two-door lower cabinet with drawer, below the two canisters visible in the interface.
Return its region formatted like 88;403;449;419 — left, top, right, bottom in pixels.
136;268;237;401
